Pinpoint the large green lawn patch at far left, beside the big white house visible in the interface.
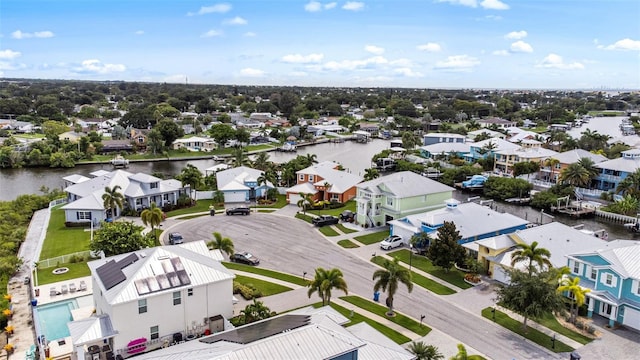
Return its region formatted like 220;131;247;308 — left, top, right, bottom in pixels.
40;208;91;259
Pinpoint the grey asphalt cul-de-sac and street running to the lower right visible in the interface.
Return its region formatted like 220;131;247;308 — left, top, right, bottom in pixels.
163;213;569;360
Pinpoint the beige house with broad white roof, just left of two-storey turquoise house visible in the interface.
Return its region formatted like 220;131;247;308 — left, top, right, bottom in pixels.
464;222;606;284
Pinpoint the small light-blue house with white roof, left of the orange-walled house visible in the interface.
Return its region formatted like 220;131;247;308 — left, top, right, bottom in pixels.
215;166;275;203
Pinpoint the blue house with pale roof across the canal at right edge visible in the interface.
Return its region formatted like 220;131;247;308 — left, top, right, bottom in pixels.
594;149;640;191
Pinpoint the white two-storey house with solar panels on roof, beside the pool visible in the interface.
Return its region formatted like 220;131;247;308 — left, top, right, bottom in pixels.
80;241;235;359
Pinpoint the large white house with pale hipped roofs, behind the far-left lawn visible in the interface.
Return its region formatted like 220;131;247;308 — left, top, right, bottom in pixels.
62;170;189;225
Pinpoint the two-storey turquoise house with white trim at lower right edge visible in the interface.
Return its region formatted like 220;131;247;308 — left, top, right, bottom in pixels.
567;240;640;330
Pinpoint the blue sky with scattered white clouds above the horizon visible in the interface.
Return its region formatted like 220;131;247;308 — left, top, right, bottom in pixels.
0;0;640;89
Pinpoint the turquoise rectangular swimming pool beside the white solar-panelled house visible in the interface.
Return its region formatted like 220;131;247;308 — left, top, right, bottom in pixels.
37;299;78;341
